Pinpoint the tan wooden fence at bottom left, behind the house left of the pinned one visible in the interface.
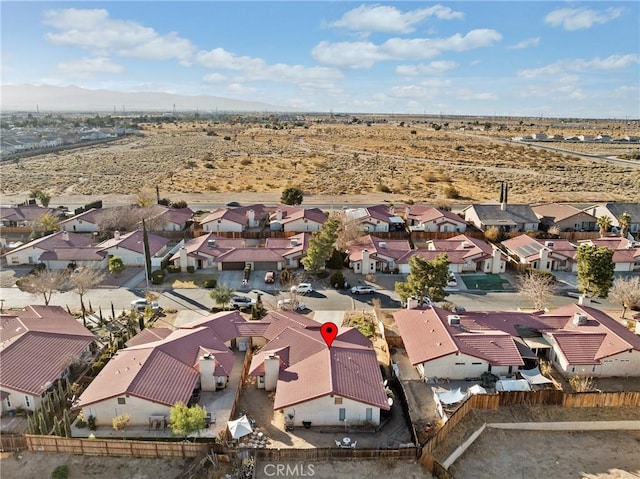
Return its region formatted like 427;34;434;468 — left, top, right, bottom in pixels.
25;434;209;458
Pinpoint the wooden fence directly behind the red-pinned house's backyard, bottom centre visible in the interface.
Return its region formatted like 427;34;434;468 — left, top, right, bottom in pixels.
255;447;418;461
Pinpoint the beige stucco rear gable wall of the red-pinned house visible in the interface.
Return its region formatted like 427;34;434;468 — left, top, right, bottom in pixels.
284;395;380;427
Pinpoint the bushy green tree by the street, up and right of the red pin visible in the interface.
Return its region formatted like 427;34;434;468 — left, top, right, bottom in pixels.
395;253;450;306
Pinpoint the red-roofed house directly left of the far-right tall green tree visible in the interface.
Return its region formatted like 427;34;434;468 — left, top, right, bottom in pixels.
500;234;578;271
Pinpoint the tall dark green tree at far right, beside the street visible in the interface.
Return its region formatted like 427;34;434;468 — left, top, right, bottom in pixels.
576;243;614;298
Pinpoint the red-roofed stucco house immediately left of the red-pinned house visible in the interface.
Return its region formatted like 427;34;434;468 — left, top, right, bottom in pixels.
76;312;248;426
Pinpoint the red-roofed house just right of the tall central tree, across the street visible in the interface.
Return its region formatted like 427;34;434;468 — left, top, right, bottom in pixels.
347;235;411;275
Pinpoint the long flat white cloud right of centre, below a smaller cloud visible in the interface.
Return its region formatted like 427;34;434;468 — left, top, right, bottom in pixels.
311;29;502;69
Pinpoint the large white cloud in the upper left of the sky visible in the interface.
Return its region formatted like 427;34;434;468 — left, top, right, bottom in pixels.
43;8;195;62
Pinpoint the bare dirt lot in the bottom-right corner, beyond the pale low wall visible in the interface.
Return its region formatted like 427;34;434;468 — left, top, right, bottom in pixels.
449;429;640;479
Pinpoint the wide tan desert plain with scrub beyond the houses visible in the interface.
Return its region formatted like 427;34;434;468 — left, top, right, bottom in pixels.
0;116;640;205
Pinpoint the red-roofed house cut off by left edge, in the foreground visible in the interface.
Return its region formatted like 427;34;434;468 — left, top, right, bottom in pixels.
0;306;95;413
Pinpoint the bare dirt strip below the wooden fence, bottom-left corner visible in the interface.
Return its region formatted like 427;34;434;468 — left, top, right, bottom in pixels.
0;452;188;479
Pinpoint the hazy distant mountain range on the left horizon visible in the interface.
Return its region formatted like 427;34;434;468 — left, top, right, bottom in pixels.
0;85;296;113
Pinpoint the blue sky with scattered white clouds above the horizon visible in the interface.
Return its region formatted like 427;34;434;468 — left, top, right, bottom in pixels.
0;1;640;119
